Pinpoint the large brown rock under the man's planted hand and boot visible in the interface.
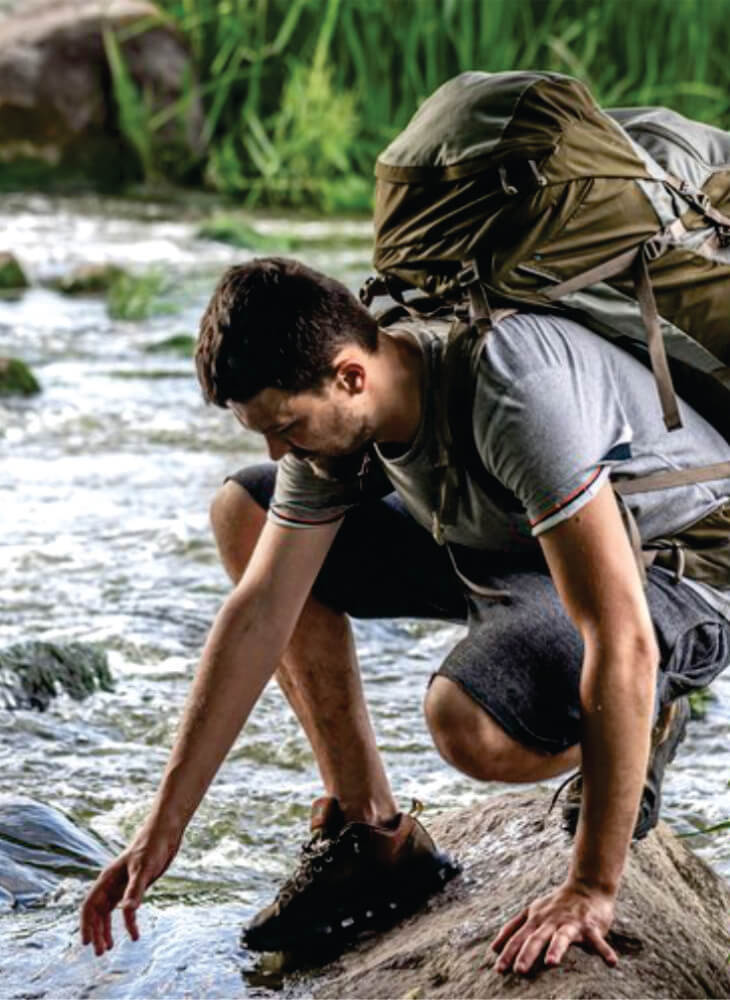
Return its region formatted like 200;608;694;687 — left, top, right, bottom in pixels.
308;792;730;1000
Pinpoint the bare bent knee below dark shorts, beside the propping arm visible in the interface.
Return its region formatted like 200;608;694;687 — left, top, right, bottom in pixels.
425;677;580;782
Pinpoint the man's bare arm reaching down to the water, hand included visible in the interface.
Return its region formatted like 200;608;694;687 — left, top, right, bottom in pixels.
81;522;341;955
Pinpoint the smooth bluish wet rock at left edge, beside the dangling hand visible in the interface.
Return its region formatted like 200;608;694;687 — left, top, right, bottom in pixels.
0;796;112;905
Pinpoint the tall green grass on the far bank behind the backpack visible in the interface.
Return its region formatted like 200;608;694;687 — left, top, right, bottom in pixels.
105;0;730;211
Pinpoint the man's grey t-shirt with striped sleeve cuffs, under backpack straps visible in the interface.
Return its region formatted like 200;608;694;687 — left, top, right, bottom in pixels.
269;313;730;615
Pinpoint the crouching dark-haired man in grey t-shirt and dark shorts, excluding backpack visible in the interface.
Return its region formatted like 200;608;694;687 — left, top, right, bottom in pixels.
82;258;730;972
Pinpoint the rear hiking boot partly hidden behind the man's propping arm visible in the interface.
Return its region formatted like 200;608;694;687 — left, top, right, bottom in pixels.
551;697;690;840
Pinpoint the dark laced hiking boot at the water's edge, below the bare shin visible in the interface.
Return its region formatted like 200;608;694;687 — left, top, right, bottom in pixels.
242;798;460;951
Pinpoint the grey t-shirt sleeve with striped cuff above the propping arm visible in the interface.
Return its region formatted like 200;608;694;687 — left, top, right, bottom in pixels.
475;366;631;535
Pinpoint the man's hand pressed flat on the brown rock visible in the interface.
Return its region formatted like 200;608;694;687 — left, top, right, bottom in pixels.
492;880;618;973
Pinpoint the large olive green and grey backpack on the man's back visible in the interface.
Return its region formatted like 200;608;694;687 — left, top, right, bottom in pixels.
361;72;730;583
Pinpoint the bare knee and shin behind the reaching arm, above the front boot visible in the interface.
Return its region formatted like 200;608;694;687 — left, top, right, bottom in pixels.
211;481;397;823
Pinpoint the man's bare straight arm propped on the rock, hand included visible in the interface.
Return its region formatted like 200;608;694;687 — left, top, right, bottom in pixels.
493;483;659;973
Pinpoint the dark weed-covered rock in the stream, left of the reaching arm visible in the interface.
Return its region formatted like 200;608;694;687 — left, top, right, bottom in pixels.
0;642;113;710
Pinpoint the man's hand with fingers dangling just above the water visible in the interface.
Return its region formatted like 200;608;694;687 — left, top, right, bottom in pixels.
81;828;180;955
